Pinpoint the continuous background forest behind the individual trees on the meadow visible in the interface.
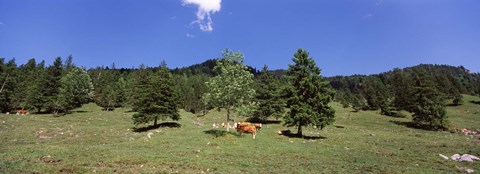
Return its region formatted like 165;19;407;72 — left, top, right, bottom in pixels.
0;56;480;123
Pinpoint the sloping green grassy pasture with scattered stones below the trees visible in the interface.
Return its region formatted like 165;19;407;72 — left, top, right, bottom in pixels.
0;96;480;173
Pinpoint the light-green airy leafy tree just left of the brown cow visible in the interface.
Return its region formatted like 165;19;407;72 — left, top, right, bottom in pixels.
204;49;256;131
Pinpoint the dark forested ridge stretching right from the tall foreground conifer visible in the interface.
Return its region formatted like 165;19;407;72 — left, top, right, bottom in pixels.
329;64;480;114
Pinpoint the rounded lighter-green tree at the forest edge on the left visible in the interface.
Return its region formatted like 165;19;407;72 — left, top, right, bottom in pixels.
53;67;93;115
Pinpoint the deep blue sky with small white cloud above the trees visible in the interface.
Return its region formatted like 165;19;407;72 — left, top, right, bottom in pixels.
0;0;480;76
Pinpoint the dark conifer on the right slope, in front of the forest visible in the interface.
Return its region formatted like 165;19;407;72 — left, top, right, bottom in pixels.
413;68;447;129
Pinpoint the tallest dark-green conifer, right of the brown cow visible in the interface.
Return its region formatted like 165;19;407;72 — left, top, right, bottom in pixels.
284;49;335;136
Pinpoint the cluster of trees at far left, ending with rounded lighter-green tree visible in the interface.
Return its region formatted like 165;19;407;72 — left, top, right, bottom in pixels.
0;56;93;114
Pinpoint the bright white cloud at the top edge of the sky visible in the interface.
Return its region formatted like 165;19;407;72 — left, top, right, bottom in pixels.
182;0;222;31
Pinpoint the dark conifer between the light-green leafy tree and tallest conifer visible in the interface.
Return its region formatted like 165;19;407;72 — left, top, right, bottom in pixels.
253;65;283;120
